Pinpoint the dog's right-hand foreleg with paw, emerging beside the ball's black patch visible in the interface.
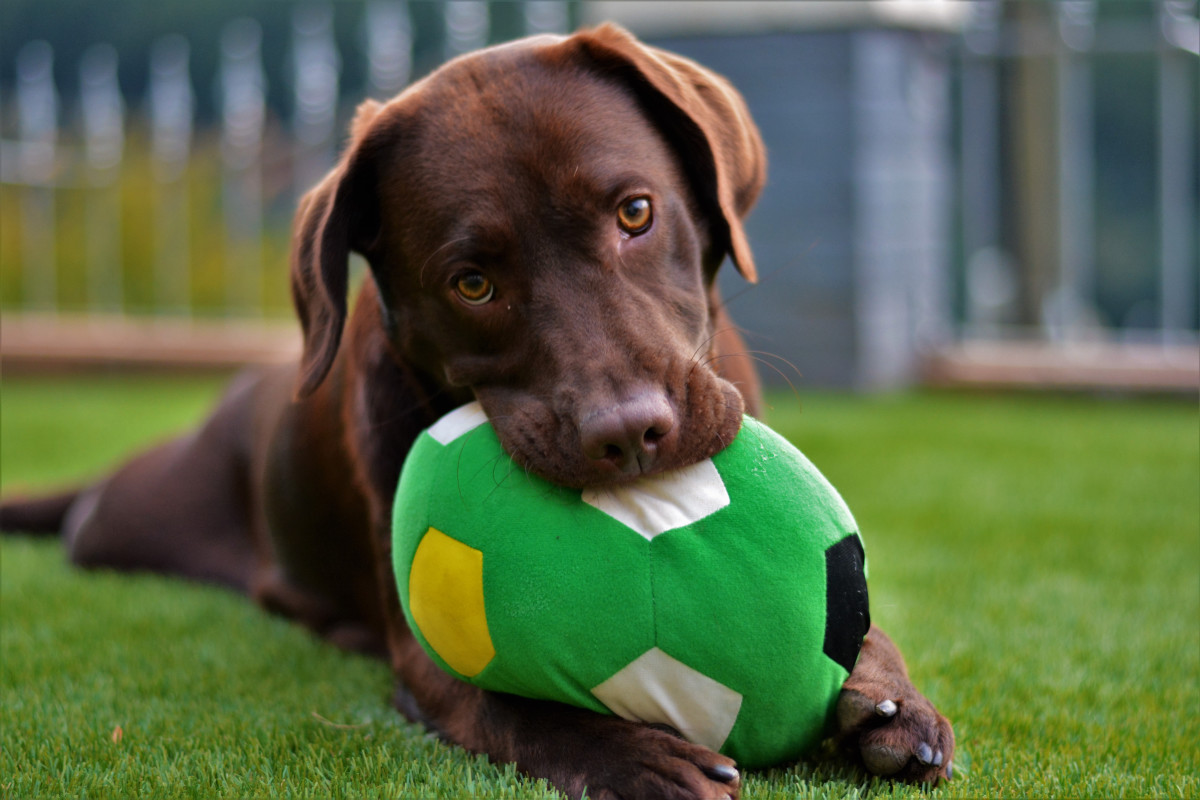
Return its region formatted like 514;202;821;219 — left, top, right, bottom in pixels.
838;625;954;783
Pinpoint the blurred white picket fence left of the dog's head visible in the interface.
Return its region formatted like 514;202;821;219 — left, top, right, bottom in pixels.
0;0;569;317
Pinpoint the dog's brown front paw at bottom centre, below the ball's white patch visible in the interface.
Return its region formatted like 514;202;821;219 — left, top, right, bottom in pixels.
570;723;742;800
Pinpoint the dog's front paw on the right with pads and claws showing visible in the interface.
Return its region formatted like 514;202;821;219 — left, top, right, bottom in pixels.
838;681;954;784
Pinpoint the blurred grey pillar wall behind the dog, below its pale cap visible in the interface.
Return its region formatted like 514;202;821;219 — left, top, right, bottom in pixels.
654;30;949;389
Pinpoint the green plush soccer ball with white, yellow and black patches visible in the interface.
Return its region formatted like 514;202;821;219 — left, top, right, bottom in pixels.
392;403;869;768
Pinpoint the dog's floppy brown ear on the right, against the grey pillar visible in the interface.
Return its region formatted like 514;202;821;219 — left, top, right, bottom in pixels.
575;24;767;282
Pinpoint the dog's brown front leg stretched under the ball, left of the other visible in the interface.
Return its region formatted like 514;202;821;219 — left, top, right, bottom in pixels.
396;636;740;800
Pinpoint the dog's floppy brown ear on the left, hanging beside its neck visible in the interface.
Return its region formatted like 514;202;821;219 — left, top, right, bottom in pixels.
292;101;382;397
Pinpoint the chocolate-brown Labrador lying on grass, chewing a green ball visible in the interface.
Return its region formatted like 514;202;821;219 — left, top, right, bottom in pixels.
0;26;954;798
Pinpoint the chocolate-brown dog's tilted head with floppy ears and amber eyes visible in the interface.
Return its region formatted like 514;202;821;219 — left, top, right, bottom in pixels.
285;25;766;486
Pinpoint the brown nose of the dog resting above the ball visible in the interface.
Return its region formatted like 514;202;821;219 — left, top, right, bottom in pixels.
580;391;676;476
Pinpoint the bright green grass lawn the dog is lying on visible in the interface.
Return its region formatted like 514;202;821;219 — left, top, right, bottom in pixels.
0;378;1200;799
